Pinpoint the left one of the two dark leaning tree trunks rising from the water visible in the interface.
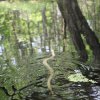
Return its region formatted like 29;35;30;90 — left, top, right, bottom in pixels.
58;0;88;62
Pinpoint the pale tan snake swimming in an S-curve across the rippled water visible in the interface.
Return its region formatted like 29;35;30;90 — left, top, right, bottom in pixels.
43;49;55;94
